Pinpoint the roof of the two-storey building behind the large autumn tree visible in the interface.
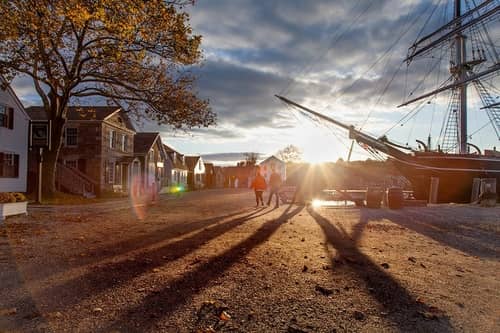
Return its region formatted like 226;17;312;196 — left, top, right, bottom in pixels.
26;106;121;121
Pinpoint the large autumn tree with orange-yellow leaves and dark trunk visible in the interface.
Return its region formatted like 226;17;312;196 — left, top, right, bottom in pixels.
0;0;215;192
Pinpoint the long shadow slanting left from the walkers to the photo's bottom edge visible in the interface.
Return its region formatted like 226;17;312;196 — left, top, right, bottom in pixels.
102;205;304;332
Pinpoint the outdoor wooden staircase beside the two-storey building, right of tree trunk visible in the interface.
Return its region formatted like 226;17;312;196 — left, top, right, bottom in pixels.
56;163;97;198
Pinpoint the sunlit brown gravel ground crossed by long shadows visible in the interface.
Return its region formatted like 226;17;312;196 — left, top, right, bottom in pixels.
0;190;500;332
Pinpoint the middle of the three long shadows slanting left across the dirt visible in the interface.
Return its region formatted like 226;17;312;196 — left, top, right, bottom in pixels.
30;209;271;311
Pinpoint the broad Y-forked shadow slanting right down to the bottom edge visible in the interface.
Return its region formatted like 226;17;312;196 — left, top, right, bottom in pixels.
308;208;453;332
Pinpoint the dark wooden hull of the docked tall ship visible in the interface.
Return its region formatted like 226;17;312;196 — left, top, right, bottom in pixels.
392;153;500;203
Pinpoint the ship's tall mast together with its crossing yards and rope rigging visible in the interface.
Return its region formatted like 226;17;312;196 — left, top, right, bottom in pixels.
398;0;500;154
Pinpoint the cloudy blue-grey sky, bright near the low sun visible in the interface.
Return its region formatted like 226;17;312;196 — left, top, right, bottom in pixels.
13;0;500;164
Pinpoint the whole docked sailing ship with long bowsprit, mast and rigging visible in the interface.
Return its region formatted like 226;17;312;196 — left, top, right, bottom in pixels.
276;0;500;203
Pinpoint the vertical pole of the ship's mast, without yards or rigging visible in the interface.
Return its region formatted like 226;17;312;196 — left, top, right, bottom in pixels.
450;0;467;154
